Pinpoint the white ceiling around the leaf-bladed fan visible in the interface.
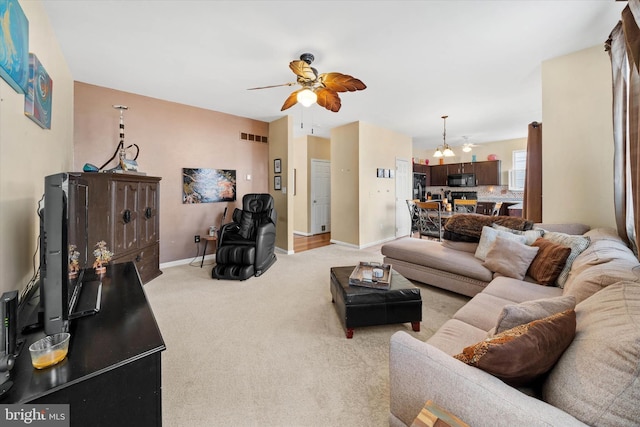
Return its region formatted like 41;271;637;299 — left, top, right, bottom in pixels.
43;0;626;149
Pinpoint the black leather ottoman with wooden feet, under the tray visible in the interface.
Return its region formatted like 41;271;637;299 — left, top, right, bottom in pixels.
331;265;422;338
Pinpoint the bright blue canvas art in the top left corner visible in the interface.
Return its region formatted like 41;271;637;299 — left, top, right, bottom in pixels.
0;0;29;93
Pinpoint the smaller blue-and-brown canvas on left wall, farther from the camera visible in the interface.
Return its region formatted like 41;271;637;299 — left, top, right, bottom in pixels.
24;53;53;129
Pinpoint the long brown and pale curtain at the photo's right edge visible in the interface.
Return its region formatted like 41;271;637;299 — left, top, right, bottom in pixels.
606;0;640;256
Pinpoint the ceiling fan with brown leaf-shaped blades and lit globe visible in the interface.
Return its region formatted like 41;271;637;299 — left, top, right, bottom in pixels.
248;53;367;113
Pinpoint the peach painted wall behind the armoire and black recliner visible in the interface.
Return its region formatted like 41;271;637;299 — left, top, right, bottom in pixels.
74;82;270;263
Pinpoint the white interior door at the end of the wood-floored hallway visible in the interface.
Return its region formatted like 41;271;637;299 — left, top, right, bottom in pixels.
311;159;331;234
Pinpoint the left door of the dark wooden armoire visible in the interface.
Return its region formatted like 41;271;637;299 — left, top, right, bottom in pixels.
112;181;139;253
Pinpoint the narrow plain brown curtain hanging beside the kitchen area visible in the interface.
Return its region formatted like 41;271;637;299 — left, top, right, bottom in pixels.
522;122;542;222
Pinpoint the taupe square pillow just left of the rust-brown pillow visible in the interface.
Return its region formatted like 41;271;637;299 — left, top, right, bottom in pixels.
483;236;539;280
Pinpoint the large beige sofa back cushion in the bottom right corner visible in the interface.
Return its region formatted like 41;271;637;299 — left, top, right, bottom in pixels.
542;282;640;426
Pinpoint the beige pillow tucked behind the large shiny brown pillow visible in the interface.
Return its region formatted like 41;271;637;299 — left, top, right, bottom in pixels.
490;296;576;334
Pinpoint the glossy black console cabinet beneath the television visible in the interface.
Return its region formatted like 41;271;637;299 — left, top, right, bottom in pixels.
5;262;165;427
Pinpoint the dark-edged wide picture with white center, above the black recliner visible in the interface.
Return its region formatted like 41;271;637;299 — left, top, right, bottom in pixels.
182;168;236;204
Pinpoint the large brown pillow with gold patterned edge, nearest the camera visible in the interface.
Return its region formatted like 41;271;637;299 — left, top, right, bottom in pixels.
453;310;576;386
